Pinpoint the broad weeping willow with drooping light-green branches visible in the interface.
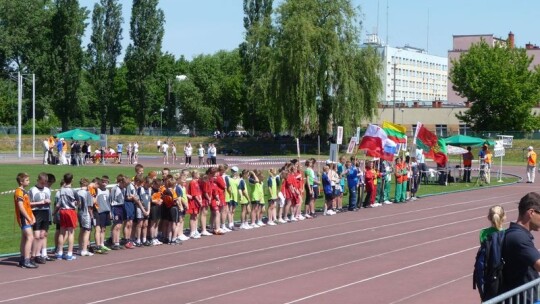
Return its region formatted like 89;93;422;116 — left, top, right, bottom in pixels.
273;0;382;134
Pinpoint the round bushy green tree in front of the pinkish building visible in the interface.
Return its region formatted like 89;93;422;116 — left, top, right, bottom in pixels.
450;41;540;131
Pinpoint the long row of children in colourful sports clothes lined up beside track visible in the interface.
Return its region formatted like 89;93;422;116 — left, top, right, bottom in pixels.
15;158;424;268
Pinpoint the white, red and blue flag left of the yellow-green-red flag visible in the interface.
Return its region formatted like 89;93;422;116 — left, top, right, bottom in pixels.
358;125;397;161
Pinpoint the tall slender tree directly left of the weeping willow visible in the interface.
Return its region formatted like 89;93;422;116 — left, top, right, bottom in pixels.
239;0;274;132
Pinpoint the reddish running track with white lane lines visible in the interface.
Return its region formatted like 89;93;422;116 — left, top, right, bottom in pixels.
0;163;537;304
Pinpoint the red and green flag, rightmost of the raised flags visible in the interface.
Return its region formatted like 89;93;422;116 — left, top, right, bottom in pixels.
414;122;448;167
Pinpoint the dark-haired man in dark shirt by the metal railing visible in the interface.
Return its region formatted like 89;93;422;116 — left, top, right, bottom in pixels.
502;192;540;303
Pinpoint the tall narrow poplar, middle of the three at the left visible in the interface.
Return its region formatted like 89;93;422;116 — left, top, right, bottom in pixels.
87;0;123;134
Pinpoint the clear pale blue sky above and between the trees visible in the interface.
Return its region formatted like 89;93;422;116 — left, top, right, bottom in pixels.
79;0;540;59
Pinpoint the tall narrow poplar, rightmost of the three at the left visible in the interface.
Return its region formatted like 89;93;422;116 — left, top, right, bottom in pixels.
125;0;165;132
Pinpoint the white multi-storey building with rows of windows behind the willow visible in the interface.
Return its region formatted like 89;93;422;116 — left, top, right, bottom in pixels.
363;34;448;106
